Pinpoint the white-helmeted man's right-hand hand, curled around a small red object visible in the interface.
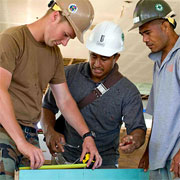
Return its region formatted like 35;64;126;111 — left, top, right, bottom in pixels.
119;135;136;153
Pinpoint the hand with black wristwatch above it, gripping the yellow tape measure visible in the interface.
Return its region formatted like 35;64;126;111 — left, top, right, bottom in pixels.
80;136;102;169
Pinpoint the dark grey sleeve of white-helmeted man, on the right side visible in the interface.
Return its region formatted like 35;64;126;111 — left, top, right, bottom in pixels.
122;86;146;134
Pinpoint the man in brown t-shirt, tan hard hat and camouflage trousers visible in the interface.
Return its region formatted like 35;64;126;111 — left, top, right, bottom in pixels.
0;0;102;179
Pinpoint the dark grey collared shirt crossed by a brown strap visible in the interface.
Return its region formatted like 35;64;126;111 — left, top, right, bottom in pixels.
43;63;146;165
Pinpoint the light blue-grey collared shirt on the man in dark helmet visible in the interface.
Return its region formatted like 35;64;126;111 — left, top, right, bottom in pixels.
146;38;180;170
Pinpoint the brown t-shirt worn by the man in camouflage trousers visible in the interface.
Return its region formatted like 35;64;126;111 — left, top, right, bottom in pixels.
0;25;66;127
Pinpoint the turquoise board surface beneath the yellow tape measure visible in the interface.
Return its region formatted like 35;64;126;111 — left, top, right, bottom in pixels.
18;169;149;180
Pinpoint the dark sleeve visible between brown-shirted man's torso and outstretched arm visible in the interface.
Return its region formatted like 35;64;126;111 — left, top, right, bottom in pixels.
42;87;59;114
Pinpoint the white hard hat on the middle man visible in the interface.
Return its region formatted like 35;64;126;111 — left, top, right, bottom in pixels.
86;21;124;57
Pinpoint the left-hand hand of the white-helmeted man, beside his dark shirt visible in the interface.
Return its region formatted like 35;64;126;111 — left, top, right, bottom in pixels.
45;130;65;156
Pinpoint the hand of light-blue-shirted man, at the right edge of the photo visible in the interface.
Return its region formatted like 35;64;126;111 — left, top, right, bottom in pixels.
170;150;180;178
